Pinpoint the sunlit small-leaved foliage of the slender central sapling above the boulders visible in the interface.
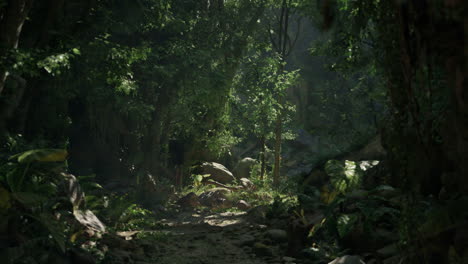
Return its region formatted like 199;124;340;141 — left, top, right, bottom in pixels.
232;51;299;139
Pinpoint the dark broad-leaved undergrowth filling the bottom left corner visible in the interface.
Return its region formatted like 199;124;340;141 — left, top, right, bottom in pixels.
0;149;71;263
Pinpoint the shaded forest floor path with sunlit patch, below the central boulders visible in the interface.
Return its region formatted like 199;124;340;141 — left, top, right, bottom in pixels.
103;210;299;264
